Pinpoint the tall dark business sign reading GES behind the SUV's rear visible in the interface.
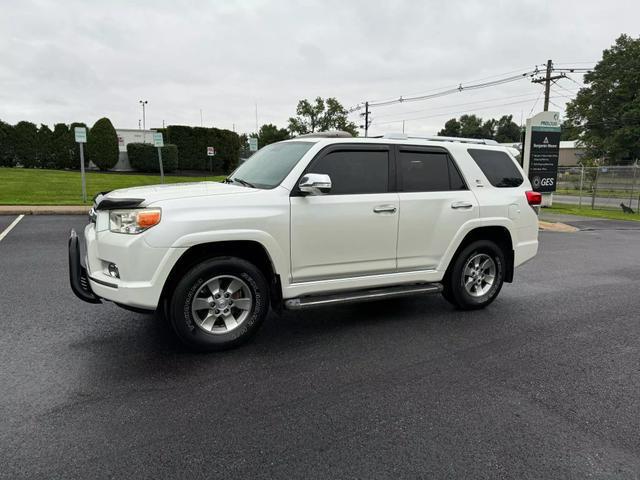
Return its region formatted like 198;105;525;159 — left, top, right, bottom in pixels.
522;112;560;206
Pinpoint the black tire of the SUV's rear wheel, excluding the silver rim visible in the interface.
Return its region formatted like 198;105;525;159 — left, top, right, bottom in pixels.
450;240;505;309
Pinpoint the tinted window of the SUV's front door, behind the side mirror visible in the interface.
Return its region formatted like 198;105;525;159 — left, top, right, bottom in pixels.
308;150;389;195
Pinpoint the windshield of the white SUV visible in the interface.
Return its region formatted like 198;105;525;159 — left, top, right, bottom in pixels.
229;142;314;188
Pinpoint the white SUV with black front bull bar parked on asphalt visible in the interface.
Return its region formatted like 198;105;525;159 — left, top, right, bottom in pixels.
69;134;541;350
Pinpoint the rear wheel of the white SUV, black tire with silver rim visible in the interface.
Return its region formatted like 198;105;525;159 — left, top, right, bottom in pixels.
443;240;505;310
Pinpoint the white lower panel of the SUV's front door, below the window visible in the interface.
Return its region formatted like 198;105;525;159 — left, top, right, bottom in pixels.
291;193;399;282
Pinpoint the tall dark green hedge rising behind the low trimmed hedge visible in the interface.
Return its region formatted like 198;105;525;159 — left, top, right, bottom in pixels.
157;125;241;173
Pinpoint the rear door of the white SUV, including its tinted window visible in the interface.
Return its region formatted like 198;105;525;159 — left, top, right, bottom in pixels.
396;145;479;271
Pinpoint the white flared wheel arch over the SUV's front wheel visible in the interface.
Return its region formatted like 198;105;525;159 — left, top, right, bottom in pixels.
160;240;282;308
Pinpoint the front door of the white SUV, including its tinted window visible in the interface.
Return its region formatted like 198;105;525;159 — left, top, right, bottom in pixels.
291;144;399;282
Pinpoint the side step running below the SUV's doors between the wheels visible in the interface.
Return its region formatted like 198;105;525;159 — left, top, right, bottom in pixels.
284;283;442;310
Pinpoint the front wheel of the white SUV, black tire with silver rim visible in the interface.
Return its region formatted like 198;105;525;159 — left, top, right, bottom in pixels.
168;257;269;351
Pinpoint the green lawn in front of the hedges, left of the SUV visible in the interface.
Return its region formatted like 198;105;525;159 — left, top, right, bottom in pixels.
0;168;225;205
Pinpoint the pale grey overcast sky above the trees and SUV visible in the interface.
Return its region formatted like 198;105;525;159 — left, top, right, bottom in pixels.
0;0;640;134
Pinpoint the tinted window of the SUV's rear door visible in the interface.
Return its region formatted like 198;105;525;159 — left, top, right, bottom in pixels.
399;150;466;192
